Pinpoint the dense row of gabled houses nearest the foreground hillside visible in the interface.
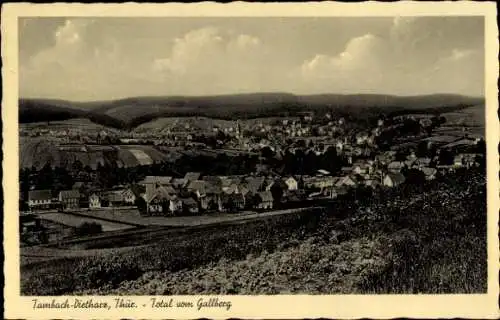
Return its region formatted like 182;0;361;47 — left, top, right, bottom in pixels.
136;151;449;214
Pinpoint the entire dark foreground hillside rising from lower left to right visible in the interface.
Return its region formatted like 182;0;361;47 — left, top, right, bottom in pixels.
21;171;487;295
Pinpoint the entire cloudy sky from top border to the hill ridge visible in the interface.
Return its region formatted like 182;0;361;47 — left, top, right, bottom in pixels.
19;17;484;101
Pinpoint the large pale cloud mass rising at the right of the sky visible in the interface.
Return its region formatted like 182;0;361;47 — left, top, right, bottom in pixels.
300;17;484;95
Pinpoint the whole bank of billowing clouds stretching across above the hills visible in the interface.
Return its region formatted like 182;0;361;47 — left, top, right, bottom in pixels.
20;17;484;100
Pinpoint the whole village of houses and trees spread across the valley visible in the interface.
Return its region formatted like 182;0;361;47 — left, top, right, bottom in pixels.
20;107;484;242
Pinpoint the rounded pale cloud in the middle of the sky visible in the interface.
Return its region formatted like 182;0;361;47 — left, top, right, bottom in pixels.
151;27;266;94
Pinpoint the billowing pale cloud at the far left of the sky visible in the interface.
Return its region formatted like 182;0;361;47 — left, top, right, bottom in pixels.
20;19;127;100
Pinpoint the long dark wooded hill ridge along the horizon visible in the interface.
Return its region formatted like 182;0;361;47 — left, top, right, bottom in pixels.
19;93;484;130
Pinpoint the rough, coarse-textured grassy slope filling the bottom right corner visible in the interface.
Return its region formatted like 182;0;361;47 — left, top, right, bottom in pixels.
90;170;487;295
